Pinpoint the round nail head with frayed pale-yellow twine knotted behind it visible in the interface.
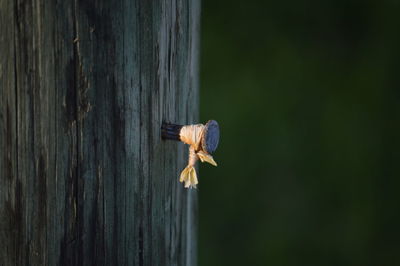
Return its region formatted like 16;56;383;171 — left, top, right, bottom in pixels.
179;120;219;188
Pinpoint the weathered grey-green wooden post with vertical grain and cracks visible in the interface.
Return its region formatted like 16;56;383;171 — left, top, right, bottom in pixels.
0;0;200;265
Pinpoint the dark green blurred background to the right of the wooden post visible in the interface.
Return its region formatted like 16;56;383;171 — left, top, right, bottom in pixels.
199;0;400;266
